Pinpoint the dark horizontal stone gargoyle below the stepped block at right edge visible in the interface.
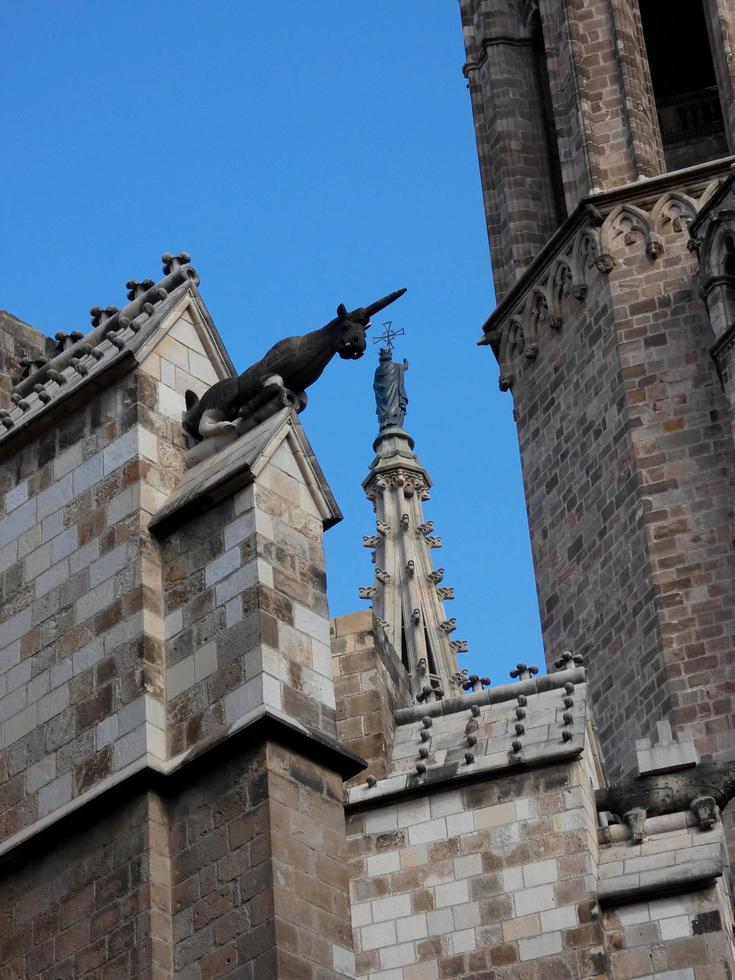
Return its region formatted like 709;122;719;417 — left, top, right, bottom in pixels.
595;762;735;843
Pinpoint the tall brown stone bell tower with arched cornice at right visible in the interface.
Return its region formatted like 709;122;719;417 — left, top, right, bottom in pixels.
460;0;735;776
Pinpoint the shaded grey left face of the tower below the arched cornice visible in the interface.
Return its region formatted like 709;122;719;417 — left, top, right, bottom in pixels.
513;262;669;775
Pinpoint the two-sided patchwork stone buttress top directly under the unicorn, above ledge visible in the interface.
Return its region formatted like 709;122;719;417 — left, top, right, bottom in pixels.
161;430;336;755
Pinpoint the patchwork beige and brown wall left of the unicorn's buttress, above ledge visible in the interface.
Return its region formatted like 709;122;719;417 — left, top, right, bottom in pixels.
0;309;224;838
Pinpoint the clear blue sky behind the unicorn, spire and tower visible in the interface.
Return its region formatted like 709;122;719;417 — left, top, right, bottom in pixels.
0;0;543;683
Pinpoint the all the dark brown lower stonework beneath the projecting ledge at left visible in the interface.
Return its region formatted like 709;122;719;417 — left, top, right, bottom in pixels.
0;741;352;980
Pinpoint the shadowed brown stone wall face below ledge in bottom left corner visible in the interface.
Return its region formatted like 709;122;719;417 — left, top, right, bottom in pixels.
0;793;151;980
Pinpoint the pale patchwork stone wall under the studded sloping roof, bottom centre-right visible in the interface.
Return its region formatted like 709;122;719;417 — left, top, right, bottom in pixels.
347;762;602;980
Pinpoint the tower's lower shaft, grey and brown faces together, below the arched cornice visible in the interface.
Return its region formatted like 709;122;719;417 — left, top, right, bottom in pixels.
513;201;735;788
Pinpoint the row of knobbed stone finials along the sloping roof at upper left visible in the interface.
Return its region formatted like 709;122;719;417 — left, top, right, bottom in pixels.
6;252;199;429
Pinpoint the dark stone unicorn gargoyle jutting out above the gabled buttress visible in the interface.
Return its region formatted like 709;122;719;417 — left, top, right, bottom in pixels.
184;289;406;442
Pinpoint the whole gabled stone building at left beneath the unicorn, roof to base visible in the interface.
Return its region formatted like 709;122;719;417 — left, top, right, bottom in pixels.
0;255;363;980
